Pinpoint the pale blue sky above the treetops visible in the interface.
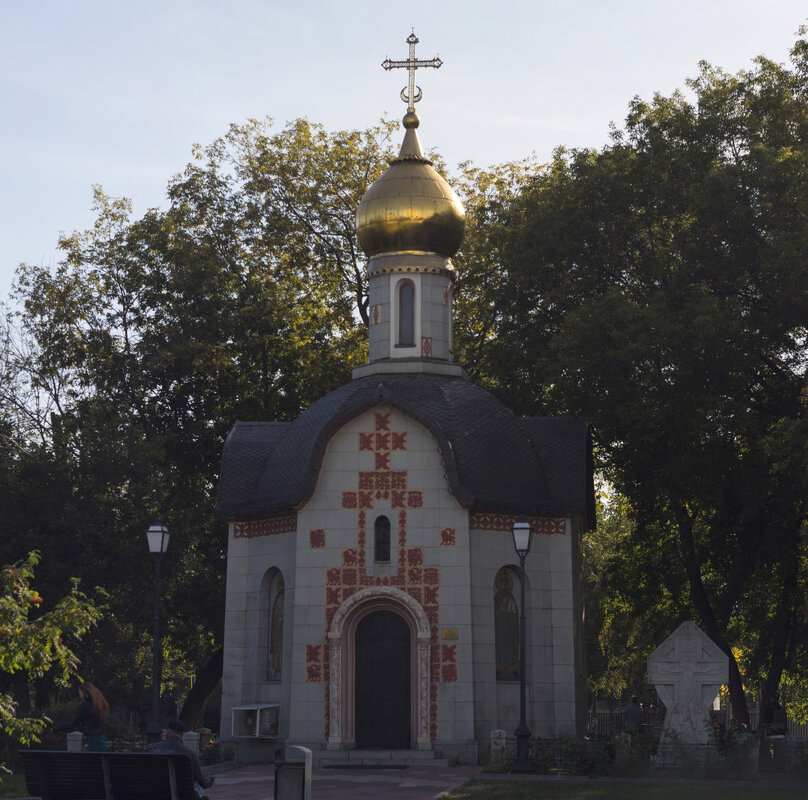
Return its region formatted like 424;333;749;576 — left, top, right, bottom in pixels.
0;0;808;302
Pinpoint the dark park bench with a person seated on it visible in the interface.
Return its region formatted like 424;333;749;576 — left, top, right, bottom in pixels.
20;750;196;800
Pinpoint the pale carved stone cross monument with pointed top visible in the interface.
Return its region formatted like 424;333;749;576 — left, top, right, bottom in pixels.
648;622;729;744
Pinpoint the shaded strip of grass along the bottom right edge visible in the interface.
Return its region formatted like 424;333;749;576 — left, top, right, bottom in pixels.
447;781;808;800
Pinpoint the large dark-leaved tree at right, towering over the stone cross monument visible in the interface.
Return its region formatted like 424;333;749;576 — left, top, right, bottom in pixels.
488;34;808;719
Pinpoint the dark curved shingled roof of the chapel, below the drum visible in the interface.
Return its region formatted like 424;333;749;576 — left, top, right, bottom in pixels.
216;374;594;527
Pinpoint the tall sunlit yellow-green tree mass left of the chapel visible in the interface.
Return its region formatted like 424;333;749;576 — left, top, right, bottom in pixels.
0;120;400;723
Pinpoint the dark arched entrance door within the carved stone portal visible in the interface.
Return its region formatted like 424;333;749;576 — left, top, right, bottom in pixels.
354;611;411;750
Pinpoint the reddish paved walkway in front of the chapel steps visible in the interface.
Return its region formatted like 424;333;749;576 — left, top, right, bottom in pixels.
207;764;480;800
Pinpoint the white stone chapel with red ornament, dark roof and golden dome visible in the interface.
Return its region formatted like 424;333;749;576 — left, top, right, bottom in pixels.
216;81;594;763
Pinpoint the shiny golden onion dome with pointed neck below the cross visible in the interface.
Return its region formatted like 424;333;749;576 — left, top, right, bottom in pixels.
356;111;466;258
